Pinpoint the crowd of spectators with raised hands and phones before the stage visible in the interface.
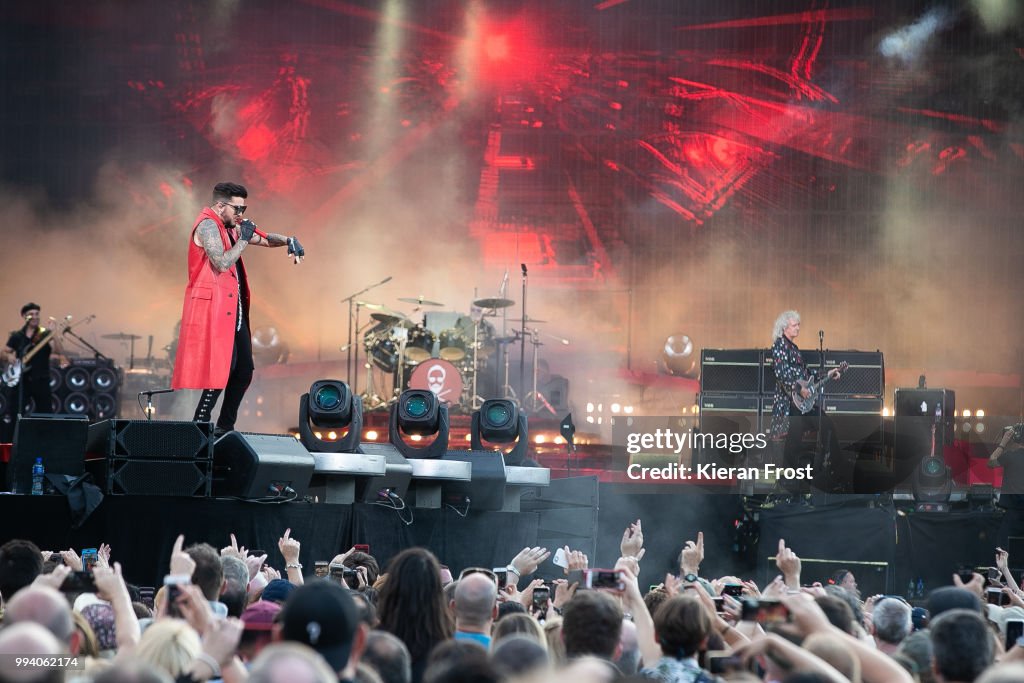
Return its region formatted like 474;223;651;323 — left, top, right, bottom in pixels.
0;520;1024;683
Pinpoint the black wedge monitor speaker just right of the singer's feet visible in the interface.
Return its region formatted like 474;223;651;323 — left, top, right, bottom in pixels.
213;431;313;500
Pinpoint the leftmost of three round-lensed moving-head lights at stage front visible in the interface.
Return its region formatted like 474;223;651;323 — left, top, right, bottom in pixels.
299;380;362;453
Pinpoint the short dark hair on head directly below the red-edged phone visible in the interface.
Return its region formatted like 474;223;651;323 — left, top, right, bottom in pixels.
562;591;623;660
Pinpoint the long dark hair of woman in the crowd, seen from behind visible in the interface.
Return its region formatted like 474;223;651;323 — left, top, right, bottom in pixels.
377;548;455;661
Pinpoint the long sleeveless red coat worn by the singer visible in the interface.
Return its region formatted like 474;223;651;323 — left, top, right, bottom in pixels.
171;207;249;389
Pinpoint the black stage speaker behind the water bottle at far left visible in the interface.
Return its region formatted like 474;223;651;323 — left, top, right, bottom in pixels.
7;415;89;494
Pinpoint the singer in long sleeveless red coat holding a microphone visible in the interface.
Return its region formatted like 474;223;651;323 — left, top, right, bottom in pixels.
171;182;305;433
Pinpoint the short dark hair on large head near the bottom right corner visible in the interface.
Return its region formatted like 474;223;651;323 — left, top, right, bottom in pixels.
931;609;992;681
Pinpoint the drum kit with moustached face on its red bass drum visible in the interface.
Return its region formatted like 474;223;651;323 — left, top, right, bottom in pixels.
357;297;539;410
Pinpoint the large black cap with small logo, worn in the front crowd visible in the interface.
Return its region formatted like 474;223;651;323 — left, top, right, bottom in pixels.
281;581;359;672
